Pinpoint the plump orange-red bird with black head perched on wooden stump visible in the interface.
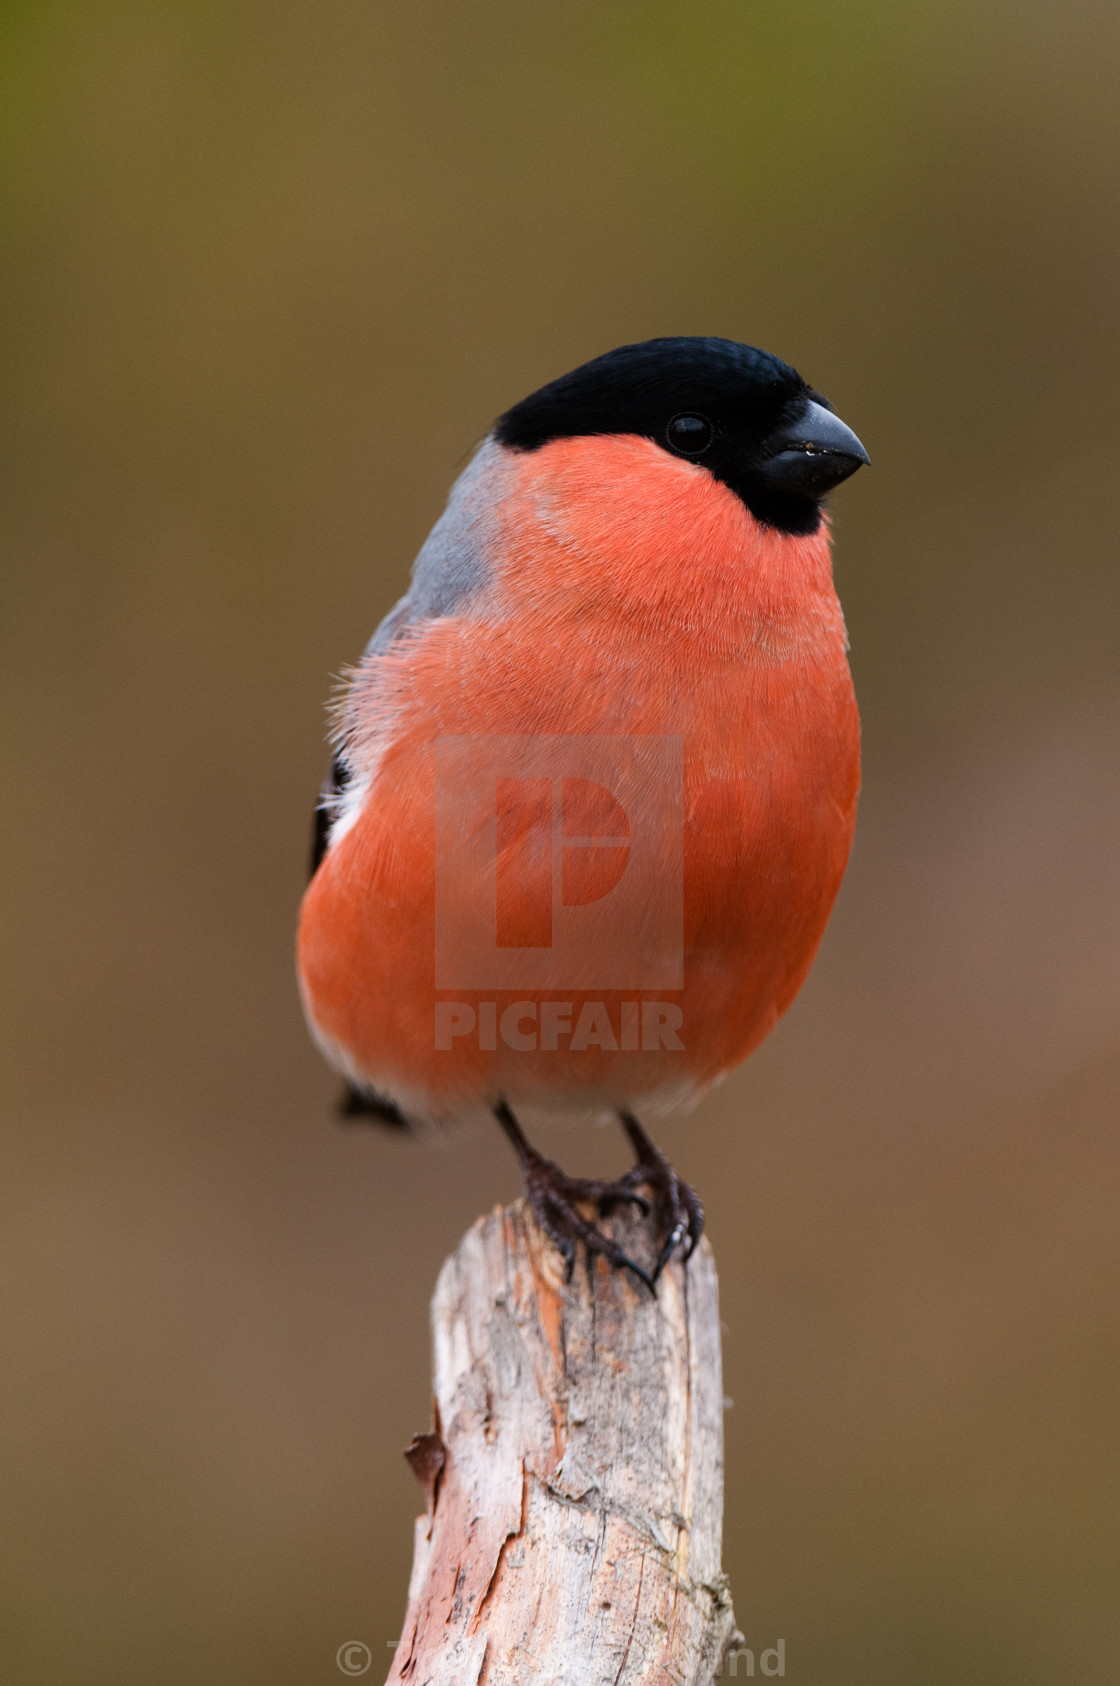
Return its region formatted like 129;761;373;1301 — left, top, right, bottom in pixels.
297;336;869;1293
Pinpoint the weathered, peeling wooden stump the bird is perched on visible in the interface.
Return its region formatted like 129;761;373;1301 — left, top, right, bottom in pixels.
390;1200;740;1686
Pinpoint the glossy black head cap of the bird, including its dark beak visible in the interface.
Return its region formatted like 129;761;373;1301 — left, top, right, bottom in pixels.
494;336;867;533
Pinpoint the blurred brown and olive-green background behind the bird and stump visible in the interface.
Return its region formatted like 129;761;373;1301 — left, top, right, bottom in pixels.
0;0;1120;1686
